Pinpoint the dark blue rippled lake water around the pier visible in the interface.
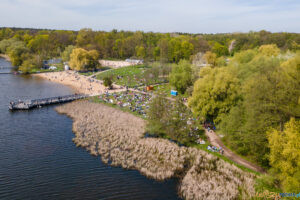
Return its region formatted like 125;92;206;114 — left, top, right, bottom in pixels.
0;59;178;200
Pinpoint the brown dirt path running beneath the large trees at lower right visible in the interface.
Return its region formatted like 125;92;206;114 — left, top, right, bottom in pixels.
205;129;265;173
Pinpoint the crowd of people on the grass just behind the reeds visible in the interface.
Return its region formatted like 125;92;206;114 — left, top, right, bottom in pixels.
99;91;151;117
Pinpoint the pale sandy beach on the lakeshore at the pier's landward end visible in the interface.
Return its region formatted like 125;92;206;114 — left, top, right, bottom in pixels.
33;71;125;95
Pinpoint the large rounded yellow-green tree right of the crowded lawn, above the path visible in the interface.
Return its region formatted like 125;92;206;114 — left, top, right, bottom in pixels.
189;68;240;123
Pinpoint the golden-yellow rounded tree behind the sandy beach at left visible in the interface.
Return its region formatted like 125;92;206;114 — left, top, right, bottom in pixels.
69;48;99;71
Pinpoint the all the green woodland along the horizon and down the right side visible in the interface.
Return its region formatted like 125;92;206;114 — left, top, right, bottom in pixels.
0;28;300;192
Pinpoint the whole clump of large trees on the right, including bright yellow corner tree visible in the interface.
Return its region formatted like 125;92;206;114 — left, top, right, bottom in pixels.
189;44;300;192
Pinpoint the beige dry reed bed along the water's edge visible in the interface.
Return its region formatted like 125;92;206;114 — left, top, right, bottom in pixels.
56;100;255;199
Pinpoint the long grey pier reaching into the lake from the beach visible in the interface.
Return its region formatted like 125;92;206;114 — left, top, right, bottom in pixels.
8;94;87;110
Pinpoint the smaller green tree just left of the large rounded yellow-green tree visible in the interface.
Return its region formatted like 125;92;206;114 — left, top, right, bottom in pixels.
169;60;193;94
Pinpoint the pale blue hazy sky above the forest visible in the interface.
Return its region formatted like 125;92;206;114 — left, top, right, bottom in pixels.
0;0;300;33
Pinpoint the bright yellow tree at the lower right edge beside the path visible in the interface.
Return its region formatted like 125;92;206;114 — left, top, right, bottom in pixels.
268;118;300;192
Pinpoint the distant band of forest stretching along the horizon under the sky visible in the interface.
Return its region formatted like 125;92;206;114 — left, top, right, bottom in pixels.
0;28;300;66
